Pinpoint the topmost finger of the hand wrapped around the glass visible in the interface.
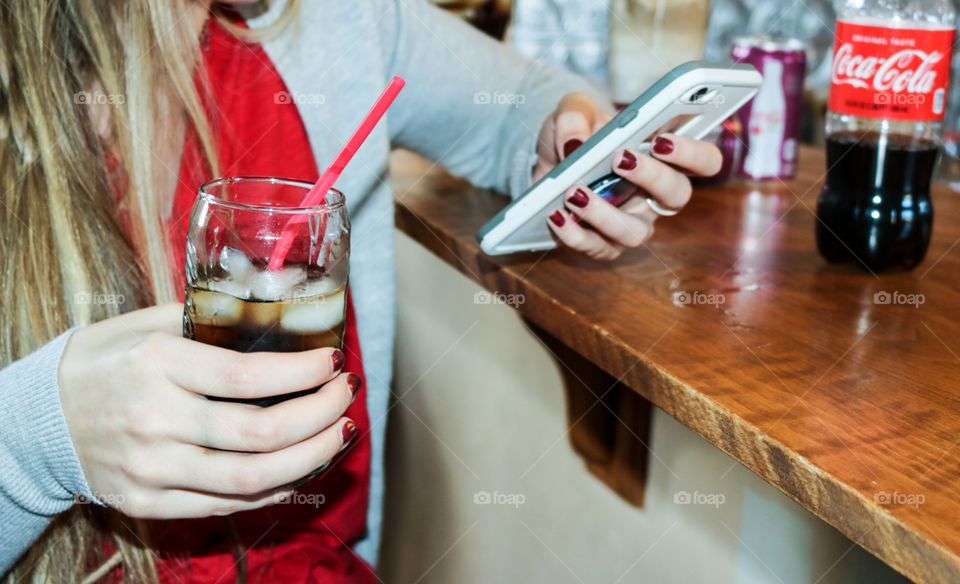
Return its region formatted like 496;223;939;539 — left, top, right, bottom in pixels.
155;335;345;399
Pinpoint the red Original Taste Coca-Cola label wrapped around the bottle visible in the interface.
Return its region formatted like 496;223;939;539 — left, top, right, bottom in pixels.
830;20;956;122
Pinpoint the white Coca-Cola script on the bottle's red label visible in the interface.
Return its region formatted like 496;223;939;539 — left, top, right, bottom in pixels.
833;43;943;93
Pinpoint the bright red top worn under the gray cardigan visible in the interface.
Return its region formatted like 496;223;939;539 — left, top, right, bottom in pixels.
142;19;376;584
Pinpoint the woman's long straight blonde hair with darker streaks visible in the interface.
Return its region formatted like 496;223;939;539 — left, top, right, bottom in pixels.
0;0;297;583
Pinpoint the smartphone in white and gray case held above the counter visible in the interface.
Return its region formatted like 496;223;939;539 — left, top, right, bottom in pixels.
477;61;763;255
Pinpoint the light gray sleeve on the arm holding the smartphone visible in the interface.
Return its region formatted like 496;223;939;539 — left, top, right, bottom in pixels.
379;0;609;196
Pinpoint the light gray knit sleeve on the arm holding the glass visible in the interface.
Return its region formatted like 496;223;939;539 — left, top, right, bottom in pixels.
0;330;94;574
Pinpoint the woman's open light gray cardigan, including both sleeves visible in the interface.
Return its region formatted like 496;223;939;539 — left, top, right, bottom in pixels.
0;0;603;572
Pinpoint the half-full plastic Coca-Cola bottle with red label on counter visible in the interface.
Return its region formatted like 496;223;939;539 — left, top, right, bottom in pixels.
817;0;956;272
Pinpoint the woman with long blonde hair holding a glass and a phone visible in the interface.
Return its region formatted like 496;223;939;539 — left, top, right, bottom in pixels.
0;0;720;582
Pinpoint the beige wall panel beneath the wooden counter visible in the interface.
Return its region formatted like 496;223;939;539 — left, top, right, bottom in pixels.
380;235;901;584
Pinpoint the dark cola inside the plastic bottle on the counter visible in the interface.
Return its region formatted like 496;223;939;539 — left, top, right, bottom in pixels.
816;132;939;272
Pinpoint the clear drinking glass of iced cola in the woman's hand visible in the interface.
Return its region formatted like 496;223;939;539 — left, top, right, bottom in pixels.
183;177;350;406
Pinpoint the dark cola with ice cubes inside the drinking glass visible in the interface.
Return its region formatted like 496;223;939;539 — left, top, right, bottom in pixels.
184;261;346;407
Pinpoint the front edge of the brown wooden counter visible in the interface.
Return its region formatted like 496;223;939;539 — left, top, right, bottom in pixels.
395;201;960;582
